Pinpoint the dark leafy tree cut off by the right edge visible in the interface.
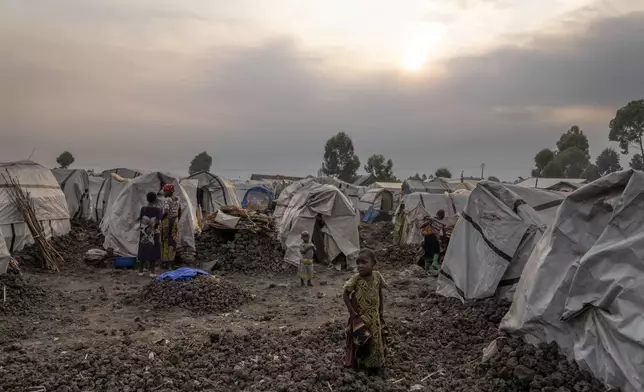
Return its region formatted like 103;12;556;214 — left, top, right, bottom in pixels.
608;99;644;156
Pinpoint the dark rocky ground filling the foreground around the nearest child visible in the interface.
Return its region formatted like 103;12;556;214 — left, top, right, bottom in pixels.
0;224;604;392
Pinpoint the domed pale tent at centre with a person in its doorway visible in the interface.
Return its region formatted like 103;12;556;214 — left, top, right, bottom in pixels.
279;181;360;269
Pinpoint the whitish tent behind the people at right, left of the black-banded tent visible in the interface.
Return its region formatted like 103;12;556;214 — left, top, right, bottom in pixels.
395;192;469;245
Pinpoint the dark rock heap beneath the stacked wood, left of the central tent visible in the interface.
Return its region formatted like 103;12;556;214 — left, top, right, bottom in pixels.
197;230;293;274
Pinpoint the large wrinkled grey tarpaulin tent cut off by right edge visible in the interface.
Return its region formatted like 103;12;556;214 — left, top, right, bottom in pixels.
501;170;644;392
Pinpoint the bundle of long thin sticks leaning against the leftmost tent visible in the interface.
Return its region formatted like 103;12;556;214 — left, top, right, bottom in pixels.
0;170;64;271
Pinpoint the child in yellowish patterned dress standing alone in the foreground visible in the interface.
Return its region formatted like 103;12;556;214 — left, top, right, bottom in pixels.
343;249;387;374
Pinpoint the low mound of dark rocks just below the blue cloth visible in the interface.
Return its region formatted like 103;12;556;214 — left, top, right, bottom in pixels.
124;275;251;314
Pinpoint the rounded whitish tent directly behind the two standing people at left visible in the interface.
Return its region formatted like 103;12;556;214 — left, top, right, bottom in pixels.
101;172;197;256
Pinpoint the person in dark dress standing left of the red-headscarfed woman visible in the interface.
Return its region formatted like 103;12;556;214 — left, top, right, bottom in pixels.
137;192;163;277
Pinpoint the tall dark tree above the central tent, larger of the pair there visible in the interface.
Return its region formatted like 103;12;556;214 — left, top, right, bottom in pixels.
322;132;360;182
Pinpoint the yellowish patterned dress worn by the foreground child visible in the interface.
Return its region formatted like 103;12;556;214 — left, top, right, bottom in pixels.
344;271;387;368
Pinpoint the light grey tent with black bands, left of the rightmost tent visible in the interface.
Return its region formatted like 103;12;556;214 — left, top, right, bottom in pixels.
437;181;563;300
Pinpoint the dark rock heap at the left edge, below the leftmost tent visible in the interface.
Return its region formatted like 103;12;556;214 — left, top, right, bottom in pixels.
0;274;53;316
